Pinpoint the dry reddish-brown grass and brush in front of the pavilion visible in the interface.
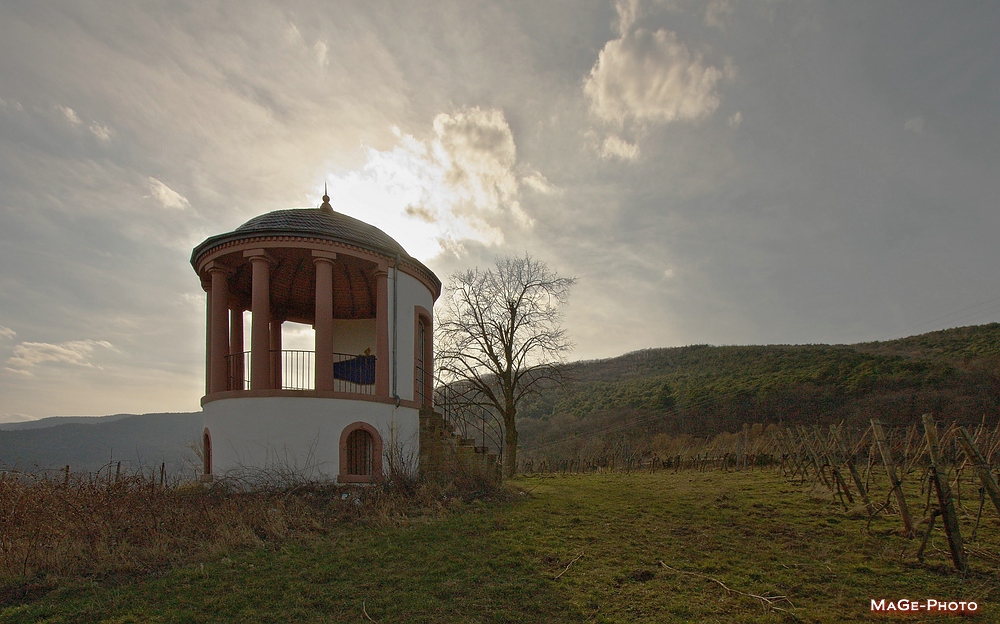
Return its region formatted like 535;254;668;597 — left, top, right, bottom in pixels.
0;465;501;604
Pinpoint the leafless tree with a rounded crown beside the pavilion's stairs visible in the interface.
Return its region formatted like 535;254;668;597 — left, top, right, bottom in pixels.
436;254;576;477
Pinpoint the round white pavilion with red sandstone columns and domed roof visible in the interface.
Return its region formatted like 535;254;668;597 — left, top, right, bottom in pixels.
191;195;441;483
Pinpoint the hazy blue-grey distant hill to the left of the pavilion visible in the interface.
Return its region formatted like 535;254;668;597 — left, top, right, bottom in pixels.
0;412;202;474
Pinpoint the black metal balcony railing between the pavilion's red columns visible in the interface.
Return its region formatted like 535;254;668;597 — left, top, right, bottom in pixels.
226;349;375;394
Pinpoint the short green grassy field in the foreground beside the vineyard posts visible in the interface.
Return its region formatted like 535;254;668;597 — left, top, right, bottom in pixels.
0;471;1000;623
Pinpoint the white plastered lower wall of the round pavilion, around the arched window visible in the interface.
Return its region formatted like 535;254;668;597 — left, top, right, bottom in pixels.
202;397;420;481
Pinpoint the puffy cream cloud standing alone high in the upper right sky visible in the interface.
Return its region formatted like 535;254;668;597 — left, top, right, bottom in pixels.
584;29;723;124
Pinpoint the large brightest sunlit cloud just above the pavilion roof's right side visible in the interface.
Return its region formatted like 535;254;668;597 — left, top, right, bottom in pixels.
329;107;540;257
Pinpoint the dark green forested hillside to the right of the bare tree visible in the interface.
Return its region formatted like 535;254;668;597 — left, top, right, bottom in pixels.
519;323;1000;453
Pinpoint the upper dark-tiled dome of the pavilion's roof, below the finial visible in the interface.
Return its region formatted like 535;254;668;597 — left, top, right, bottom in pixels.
233;208;410;259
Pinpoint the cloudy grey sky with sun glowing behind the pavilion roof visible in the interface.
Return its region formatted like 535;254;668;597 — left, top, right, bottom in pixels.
0;0;1000;421
